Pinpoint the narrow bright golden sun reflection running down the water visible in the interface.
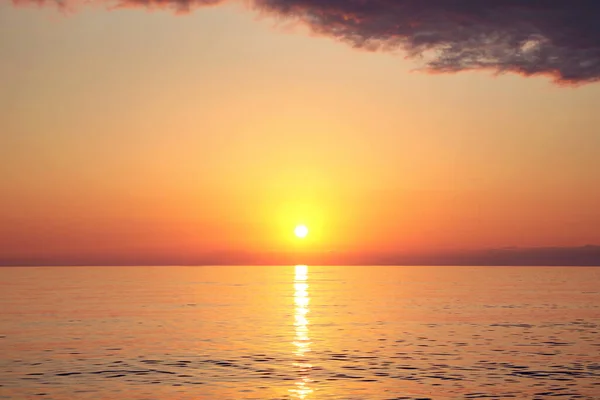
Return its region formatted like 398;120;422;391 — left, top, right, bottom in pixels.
290;265;313;399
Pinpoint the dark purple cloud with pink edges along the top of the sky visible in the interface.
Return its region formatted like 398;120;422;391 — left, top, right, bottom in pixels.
14;0;600;85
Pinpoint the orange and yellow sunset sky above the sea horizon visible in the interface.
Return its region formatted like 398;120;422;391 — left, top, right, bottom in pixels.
0;0;600;265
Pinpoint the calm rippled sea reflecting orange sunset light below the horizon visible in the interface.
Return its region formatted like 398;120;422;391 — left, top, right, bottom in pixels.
0;266;600;400
